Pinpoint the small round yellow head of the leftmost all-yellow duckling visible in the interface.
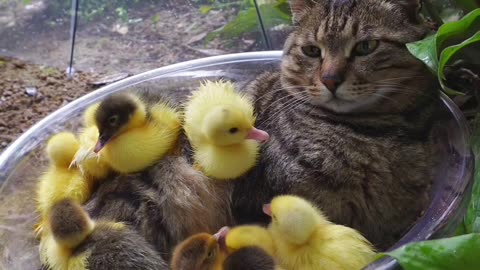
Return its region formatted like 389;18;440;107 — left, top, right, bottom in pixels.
46;132;80;167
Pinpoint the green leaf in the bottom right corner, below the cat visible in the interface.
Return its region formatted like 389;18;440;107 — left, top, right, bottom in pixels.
383;234;480;270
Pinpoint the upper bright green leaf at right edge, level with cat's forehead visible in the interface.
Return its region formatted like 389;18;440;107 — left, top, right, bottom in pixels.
436;9;480;51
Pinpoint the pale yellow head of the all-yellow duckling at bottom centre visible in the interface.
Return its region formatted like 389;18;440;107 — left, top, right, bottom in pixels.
263;195;328;245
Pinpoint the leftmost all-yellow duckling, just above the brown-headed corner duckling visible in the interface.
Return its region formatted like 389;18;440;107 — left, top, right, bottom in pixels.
36;132;92;232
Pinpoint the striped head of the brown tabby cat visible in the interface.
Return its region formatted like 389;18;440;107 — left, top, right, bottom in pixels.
282;0;437;113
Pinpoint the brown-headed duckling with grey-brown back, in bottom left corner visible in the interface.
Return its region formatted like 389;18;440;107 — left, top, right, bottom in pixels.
40;199;168;270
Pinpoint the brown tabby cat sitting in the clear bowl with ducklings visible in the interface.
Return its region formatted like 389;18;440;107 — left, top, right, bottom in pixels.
232;0;440;249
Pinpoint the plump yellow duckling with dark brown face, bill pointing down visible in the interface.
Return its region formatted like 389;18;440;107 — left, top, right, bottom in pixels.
85;93;181;173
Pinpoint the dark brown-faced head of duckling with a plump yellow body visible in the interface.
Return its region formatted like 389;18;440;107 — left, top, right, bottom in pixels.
94;94;147;153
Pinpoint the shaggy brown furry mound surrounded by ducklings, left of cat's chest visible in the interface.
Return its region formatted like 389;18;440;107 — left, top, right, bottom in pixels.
85;154;233;261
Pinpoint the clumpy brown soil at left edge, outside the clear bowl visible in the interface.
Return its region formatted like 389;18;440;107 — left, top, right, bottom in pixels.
0;57;98;152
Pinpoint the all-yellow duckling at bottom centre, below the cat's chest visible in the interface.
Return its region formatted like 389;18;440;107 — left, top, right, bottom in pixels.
263;195;375;270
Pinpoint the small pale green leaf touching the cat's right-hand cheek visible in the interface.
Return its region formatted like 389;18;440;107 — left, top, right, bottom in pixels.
407;35;438;74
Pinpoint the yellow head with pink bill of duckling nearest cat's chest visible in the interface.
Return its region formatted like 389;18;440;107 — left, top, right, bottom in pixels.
202;106;269;146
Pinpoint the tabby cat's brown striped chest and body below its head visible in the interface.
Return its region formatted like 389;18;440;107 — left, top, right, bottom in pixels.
233;71;432;247
